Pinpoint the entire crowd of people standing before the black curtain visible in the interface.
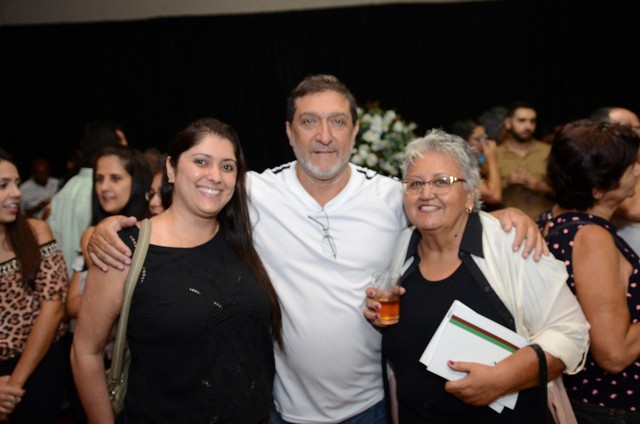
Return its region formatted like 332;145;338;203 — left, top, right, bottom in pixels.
0;75;640;424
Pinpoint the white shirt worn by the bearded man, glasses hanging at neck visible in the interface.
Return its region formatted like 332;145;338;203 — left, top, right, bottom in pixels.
247;161;407;423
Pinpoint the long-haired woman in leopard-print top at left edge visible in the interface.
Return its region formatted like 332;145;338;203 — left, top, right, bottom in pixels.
0;150;68;424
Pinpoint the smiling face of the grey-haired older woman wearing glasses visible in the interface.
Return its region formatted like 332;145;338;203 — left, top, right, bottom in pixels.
404;151;474;235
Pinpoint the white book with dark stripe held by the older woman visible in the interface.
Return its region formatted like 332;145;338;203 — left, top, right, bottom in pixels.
420;300;529;412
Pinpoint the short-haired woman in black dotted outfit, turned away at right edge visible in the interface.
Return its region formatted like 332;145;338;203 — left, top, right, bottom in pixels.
539;121;640;423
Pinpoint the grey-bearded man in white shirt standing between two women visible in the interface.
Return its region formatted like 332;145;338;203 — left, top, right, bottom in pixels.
249;75;407;423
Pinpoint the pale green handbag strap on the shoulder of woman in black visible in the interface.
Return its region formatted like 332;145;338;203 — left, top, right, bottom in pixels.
109;218;151;387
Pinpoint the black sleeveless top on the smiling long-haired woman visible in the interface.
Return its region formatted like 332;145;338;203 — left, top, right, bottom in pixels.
118;228;274;424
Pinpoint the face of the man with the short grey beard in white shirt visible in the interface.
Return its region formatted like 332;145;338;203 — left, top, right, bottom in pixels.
287;90;359;181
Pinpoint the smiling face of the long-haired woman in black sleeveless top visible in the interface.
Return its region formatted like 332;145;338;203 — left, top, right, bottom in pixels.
167;133;238;218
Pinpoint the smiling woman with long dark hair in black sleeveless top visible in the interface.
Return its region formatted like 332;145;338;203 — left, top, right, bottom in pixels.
71;118;282;424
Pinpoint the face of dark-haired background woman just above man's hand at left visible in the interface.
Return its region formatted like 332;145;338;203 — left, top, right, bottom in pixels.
94;155;133;215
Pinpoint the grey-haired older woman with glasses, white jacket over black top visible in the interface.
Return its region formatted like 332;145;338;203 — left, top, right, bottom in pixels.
365;130;589;424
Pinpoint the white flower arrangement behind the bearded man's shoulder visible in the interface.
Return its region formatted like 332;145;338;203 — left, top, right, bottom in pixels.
351;103;418;177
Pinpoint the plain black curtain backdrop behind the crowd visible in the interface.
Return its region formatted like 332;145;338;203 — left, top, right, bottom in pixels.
0;1;640;179
